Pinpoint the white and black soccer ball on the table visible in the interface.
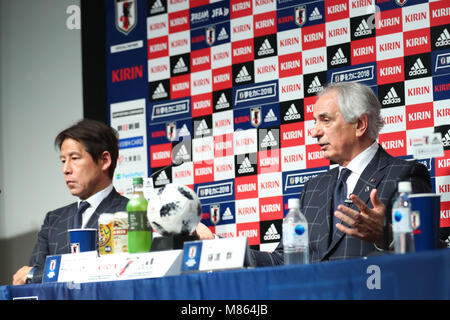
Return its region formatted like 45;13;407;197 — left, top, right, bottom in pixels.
147;183;202;236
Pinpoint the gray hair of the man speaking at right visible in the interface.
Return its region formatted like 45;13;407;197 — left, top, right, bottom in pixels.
318;82;384;139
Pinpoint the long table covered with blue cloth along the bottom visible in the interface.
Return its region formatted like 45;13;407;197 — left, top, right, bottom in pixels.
0;249;450;300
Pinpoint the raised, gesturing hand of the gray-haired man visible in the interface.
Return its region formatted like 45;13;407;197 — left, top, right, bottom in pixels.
334;189;386;248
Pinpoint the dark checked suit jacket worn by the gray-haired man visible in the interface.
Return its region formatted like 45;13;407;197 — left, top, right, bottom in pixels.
252;146;432;266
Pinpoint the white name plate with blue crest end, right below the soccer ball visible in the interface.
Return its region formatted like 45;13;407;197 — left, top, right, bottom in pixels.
181;237;248;272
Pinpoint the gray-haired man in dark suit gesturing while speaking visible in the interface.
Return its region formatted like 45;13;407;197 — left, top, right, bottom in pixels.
197;82;432;266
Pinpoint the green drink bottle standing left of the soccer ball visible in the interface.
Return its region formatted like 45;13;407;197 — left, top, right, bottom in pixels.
127;178;152;253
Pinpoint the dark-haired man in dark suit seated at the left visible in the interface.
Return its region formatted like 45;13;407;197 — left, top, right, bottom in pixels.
13;119;128;285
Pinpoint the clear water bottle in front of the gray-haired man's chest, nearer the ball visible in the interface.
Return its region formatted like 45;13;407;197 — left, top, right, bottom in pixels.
283;198;309;265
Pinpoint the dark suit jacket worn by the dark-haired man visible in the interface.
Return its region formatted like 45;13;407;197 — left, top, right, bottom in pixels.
29;189;128;283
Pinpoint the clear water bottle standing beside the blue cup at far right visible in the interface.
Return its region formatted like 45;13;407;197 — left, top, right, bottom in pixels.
392;181;415;253
